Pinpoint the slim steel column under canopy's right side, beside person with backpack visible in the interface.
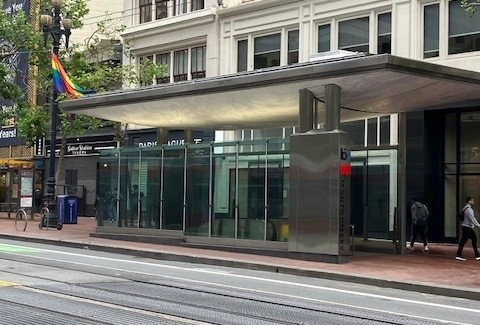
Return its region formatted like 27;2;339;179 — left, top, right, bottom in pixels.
397;113;407;255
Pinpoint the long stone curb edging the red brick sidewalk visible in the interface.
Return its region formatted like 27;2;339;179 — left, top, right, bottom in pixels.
0;234;480;301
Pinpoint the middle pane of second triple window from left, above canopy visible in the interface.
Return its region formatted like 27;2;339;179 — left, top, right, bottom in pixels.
253;34;281;69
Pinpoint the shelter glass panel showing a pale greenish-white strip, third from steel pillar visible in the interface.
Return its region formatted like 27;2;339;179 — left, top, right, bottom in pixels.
212;143;237;238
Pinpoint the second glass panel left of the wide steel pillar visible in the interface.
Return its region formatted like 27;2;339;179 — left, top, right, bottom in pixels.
237;141;267;240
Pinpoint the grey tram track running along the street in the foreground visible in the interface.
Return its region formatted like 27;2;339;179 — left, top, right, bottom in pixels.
0;259;450;325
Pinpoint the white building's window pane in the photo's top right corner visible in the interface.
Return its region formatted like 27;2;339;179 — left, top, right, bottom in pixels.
448;1;480;54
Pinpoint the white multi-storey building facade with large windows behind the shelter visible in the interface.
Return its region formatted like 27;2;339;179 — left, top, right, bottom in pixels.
91;0;480;247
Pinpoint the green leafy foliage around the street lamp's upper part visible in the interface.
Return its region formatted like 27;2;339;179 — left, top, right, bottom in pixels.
0;0;165;145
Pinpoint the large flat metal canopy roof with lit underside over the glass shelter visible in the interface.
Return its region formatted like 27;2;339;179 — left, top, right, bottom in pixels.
60;54;480;130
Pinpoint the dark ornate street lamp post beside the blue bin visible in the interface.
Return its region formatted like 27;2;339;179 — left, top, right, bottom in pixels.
40;0;72;222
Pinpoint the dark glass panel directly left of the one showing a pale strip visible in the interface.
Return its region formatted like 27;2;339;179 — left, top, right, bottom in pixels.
185;145;210;236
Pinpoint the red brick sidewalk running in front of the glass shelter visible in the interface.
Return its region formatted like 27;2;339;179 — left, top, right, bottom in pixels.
0;213;480;300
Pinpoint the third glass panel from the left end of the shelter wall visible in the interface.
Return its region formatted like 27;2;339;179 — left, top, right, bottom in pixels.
140;148;162;229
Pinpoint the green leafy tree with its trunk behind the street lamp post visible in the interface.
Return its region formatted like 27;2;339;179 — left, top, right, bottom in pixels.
2;0;165;179
